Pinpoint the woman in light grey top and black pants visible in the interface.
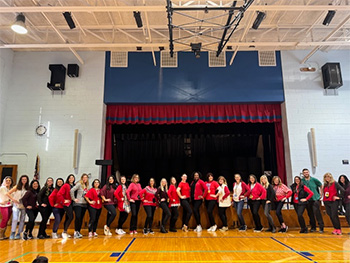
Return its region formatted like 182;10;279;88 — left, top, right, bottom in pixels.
69;173;90;238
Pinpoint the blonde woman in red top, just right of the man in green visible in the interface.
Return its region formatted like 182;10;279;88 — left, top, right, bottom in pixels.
323;173;344;235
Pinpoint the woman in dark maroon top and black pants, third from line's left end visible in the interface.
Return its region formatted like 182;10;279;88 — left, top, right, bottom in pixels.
22;180;40;240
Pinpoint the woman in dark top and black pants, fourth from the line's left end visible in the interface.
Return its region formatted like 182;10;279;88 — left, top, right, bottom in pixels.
38;177;54;239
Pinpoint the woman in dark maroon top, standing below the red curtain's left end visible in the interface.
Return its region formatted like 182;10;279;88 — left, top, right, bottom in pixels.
101;175;118;236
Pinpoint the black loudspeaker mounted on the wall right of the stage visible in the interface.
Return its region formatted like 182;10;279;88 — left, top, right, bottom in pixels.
322;63;343;89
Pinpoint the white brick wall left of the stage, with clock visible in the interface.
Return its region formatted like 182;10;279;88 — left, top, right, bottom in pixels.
0;52;105;186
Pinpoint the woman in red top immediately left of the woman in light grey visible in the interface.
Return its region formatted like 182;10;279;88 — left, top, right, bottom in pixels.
57;174;75;239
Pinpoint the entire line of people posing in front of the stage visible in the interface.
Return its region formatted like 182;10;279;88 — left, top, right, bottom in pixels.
0;169;350;240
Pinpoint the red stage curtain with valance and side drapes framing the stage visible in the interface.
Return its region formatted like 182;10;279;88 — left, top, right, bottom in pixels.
105;104;286;182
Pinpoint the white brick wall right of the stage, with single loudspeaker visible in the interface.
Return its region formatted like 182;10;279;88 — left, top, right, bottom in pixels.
281;50;350;185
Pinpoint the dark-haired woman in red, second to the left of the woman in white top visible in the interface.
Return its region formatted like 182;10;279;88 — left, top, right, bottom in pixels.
191;172;206;232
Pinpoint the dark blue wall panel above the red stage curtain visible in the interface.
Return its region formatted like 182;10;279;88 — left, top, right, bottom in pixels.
104;51;284;104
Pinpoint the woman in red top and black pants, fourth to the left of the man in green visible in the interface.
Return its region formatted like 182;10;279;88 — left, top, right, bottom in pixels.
248;174;266;232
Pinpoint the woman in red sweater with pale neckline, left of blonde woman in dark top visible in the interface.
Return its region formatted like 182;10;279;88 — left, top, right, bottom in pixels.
140;178;157;235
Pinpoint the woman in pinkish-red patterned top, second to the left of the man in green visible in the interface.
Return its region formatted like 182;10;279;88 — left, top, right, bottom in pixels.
272;176;293;233
